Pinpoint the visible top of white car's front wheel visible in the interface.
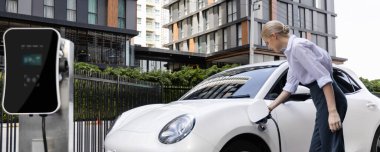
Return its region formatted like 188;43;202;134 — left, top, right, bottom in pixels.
221;140;263;152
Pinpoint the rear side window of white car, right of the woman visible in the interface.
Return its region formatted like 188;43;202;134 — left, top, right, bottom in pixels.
333;69;361;94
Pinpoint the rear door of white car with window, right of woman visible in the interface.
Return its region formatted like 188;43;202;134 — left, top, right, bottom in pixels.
334;69;380;151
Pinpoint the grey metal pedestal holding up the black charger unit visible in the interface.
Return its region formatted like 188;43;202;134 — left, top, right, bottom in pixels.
19;39;74;152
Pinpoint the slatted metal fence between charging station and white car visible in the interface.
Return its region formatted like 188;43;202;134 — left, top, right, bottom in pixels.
74;71;190;152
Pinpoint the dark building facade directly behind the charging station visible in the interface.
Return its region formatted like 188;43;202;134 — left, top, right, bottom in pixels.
0;0;138;66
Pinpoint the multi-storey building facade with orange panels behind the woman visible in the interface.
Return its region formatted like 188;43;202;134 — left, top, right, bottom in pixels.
156;0;346;65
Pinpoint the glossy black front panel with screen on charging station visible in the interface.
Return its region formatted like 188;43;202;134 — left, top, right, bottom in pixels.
3;29;59;114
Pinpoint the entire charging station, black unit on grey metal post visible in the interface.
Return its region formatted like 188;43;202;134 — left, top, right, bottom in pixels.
2;28;74;152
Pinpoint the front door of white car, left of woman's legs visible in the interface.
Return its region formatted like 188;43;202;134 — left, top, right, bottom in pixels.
265;71;316;152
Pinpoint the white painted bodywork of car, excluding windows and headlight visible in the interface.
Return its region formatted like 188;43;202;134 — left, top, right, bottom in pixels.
105;61;380;152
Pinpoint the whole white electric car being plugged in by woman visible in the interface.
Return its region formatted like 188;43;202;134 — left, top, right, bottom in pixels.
104;61;380;152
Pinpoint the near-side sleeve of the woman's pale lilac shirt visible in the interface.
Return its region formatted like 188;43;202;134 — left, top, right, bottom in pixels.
293;44;332;88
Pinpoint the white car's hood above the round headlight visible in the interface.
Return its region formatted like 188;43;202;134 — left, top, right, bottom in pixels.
114;99;252;132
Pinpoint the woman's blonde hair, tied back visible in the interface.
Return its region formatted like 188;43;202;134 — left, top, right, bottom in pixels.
261;20;289;38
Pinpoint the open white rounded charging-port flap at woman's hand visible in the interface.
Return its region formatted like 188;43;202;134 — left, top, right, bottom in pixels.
247;100;269;123
